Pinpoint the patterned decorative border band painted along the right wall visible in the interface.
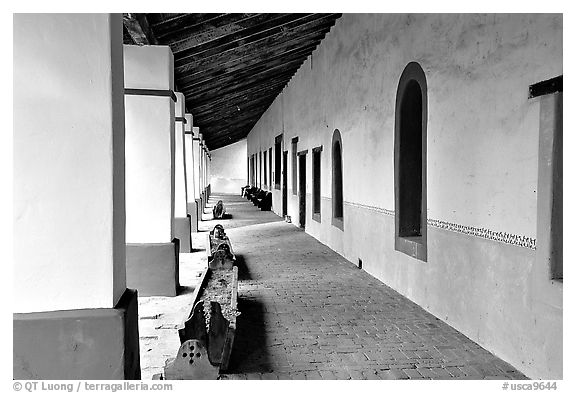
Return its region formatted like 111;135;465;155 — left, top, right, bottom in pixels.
344;201;536;250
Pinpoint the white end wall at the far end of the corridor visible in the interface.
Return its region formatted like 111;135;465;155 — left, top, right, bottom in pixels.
210;139;248;194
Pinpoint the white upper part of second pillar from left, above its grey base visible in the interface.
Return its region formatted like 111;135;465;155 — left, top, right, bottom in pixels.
124;45;173;243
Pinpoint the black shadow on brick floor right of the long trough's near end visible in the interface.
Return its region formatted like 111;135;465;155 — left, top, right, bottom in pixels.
226;298;272;374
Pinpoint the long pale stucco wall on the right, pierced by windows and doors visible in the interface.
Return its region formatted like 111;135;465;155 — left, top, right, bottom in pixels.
244;14;562;378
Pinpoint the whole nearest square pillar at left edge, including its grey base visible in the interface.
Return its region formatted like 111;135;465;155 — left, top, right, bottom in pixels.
13;14;140;379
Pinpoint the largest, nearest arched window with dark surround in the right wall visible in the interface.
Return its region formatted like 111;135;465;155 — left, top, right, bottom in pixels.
394;62;428;261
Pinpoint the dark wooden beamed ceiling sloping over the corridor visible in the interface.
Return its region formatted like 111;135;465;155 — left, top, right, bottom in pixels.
124;14;341;150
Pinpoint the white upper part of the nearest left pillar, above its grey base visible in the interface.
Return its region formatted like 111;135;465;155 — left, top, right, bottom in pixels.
12;14;126;313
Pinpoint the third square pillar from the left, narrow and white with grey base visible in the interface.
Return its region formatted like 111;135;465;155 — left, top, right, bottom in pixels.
174;93;192;253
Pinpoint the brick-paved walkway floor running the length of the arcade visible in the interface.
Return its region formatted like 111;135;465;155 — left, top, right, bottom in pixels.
139;191;525;379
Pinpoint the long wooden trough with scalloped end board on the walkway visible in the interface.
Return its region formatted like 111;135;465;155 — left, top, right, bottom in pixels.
164;225;239;380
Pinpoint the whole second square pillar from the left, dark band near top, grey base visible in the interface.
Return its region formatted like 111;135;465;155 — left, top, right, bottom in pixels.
124;45;180;296
